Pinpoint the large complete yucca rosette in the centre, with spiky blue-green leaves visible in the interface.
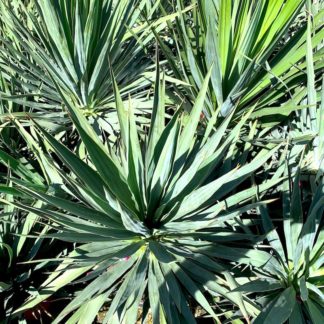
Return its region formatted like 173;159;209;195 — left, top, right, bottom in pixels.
0;69;288;323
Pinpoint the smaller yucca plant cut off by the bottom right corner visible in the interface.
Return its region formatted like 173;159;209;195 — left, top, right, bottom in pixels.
235;170;324;324
